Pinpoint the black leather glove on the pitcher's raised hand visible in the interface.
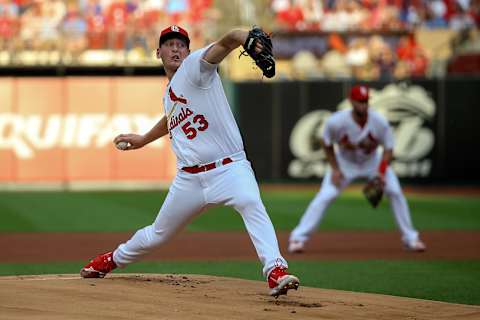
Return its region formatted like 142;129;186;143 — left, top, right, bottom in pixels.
242;27;275;78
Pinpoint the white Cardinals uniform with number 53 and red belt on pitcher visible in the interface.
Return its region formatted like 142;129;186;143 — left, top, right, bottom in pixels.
113;47;287;276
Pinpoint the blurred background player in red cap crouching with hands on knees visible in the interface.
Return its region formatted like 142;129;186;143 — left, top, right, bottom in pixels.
288;85;426;253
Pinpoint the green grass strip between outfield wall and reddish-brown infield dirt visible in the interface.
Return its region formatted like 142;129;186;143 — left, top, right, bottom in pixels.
0;191;480;232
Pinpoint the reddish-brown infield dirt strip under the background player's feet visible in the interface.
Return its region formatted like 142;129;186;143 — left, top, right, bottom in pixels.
0;230;480;262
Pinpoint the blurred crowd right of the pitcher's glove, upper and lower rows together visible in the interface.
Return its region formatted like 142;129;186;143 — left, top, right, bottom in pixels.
271;0;480;80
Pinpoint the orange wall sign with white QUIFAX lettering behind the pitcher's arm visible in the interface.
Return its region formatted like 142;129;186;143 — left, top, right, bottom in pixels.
0;77;175;183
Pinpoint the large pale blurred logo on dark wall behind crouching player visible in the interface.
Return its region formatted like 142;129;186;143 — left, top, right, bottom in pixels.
287;84;437;178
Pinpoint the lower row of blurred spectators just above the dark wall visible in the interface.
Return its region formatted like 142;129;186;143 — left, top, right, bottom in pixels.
292;33;430;81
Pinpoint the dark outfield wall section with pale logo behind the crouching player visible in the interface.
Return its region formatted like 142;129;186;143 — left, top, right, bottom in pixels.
234;78;480;183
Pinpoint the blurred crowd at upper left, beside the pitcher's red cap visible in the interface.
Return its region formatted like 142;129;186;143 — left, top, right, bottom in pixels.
0;0;216;60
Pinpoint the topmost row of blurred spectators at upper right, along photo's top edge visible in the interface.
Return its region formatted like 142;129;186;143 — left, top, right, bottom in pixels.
271;0;480;31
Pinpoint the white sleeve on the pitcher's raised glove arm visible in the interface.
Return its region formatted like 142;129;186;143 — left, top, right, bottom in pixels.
183;43;218;89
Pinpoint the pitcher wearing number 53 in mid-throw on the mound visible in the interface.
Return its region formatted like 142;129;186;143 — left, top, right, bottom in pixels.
80;25;299;297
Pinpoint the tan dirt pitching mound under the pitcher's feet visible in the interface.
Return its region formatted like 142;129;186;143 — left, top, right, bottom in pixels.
0;274;480;320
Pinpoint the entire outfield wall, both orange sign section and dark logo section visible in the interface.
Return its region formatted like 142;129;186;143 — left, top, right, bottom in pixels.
0;75;480;189
